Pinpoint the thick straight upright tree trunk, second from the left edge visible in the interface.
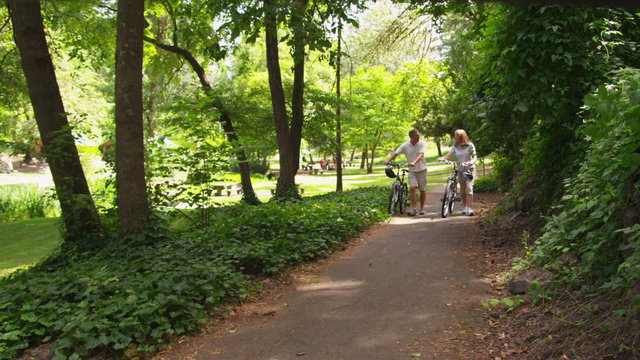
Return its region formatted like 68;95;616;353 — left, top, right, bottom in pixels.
115;0;149;233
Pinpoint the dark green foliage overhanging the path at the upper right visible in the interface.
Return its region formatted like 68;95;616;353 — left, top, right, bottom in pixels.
469;5;640;213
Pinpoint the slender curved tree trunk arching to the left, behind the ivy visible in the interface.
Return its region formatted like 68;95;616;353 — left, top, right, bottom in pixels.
144;37;260;205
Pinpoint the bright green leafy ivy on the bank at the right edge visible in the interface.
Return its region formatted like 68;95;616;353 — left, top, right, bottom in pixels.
532;70;640;292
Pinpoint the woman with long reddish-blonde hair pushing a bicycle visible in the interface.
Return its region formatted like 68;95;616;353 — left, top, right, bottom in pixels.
439;129;478;216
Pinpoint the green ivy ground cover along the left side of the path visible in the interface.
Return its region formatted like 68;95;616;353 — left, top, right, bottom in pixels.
0;187;388;359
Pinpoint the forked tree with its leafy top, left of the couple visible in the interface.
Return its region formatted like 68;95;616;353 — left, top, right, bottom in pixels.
219;0;363;199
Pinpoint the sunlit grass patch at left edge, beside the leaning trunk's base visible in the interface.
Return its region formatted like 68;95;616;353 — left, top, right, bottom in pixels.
0;218;60;276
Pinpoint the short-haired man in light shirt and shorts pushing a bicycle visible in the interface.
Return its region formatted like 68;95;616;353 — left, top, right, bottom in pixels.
385;129;427;216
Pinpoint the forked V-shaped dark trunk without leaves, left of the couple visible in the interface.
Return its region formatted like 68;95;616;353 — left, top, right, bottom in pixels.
264;0;304;200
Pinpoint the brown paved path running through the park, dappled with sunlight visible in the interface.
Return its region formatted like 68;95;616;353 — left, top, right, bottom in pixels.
158;189;489;360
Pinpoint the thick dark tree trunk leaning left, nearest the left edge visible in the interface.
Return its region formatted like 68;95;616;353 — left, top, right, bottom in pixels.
7;0;102;248
